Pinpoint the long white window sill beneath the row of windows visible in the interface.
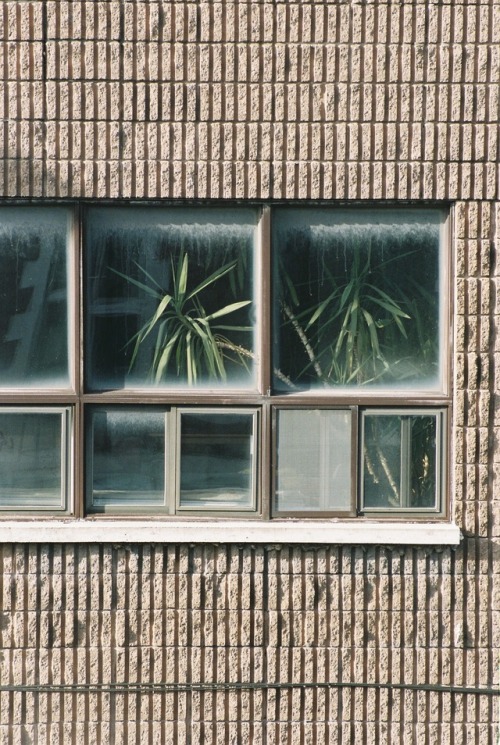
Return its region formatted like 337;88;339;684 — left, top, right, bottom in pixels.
0;518;461;546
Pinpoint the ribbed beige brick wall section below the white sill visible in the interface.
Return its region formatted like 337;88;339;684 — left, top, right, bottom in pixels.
0;541;498;745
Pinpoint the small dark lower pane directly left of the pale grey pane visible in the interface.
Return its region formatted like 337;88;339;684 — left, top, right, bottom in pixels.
180;412;256;510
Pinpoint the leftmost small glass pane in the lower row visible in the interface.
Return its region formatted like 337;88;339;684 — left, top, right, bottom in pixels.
0;411;65;510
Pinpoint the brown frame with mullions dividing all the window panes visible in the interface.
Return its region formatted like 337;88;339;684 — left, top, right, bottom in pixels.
0;202;453;522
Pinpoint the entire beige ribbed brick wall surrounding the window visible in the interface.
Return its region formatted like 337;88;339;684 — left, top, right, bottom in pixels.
0;0;500;745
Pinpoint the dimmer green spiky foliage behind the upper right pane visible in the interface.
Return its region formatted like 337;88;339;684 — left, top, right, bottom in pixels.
280;240;436;386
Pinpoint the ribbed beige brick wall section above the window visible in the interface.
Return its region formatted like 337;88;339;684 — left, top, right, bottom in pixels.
0;0;500;200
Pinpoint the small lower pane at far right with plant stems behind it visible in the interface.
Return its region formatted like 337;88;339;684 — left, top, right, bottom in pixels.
363;412;440;510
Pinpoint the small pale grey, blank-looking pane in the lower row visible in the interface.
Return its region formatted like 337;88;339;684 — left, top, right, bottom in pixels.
275;410;351;512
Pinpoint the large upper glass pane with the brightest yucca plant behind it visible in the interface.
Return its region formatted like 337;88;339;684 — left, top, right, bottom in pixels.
85;208;257;389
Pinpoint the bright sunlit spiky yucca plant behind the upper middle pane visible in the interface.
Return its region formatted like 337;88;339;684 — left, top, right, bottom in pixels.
112;251;253;385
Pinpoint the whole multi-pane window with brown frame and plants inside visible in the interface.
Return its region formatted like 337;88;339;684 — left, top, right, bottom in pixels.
0;205;450;520
